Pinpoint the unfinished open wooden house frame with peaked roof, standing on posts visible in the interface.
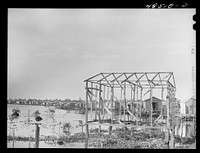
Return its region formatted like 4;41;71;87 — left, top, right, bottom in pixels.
84;72;183;148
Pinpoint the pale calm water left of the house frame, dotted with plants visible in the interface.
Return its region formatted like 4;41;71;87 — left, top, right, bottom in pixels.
7;104;85;148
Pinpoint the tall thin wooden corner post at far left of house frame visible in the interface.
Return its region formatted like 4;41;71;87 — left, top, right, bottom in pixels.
85;81;89;148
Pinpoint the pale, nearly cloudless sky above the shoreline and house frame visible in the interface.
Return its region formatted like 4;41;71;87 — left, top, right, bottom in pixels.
8;8;196;100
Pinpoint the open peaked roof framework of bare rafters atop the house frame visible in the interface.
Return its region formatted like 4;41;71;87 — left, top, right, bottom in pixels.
84;72;176;89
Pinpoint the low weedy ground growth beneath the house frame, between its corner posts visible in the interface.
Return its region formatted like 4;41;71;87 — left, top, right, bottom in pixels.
89;128;168;149
